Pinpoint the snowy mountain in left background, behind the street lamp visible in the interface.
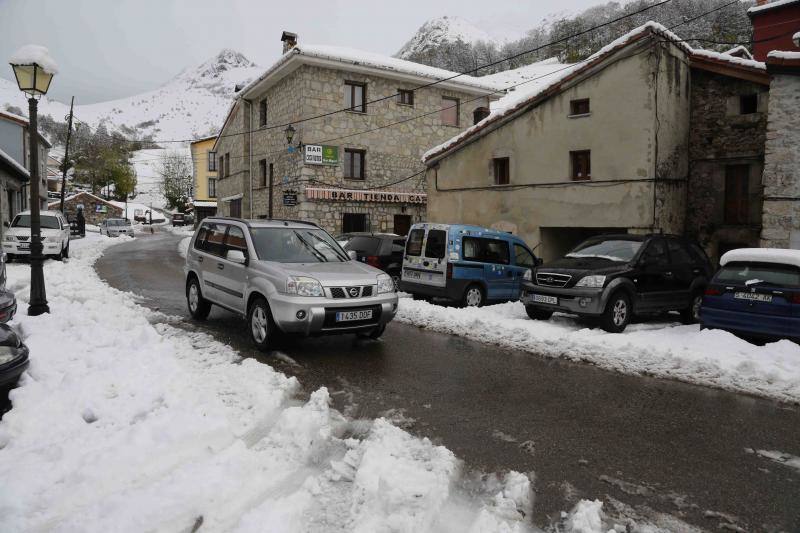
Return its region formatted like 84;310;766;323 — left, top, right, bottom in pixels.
0;49;263;140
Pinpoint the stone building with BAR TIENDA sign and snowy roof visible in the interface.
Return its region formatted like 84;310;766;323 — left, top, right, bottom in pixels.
214;32;496;234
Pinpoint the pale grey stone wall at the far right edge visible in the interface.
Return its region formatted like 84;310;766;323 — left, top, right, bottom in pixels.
761;68;800;249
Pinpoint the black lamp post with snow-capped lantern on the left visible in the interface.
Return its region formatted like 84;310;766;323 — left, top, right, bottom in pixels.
9;45;58;316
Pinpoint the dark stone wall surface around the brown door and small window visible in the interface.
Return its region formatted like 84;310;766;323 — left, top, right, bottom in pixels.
686;69;770;262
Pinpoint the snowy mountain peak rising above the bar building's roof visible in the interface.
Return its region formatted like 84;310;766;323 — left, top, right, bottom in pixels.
395;16;520;59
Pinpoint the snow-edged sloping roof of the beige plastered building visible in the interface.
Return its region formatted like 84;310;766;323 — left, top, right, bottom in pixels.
422;20;768;163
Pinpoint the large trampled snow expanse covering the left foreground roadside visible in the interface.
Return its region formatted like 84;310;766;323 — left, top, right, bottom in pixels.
0;234;531;532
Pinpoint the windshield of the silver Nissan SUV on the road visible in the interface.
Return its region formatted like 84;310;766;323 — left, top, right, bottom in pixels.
250;228;350;263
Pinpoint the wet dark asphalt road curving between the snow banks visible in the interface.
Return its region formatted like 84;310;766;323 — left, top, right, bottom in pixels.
96;233;800;531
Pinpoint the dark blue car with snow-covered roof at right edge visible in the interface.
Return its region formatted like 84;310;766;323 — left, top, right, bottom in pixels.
700;248;800;342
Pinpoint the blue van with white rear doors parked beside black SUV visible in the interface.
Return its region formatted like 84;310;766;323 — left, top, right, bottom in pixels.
400;223;540;307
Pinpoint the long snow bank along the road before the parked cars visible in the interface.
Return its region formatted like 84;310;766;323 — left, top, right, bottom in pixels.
397;298;800;402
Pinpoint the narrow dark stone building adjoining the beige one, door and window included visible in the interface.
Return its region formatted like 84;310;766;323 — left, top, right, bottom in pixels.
685;54;770;262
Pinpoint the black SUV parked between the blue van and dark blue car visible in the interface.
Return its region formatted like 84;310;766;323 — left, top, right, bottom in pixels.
520;235;714;333
